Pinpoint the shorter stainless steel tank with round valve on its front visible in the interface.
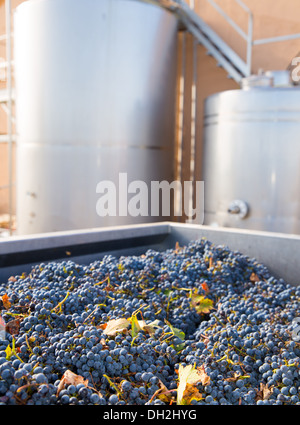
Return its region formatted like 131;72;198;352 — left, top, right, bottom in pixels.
203;76;300;234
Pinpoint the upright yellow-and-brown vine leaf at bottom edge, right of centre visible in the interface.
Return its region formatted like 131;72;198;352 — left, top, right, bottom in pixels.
177;364;210;405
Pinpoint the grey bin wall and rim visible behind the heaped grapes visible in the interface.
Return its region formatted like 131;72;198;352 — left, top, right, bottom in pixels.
0;221;300;286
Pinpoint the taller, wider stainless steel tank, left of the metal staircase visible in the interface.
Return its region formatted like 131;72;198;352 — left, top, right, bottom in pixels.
14;0;177;234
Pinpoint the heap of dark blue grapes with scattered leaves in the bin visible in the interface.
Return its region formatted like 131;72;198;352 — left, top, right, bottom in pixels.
0;239;300;405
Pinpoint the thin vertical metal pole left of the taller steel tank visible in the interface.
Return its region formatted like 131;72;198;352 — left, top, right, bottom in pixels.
5;0;13;235
